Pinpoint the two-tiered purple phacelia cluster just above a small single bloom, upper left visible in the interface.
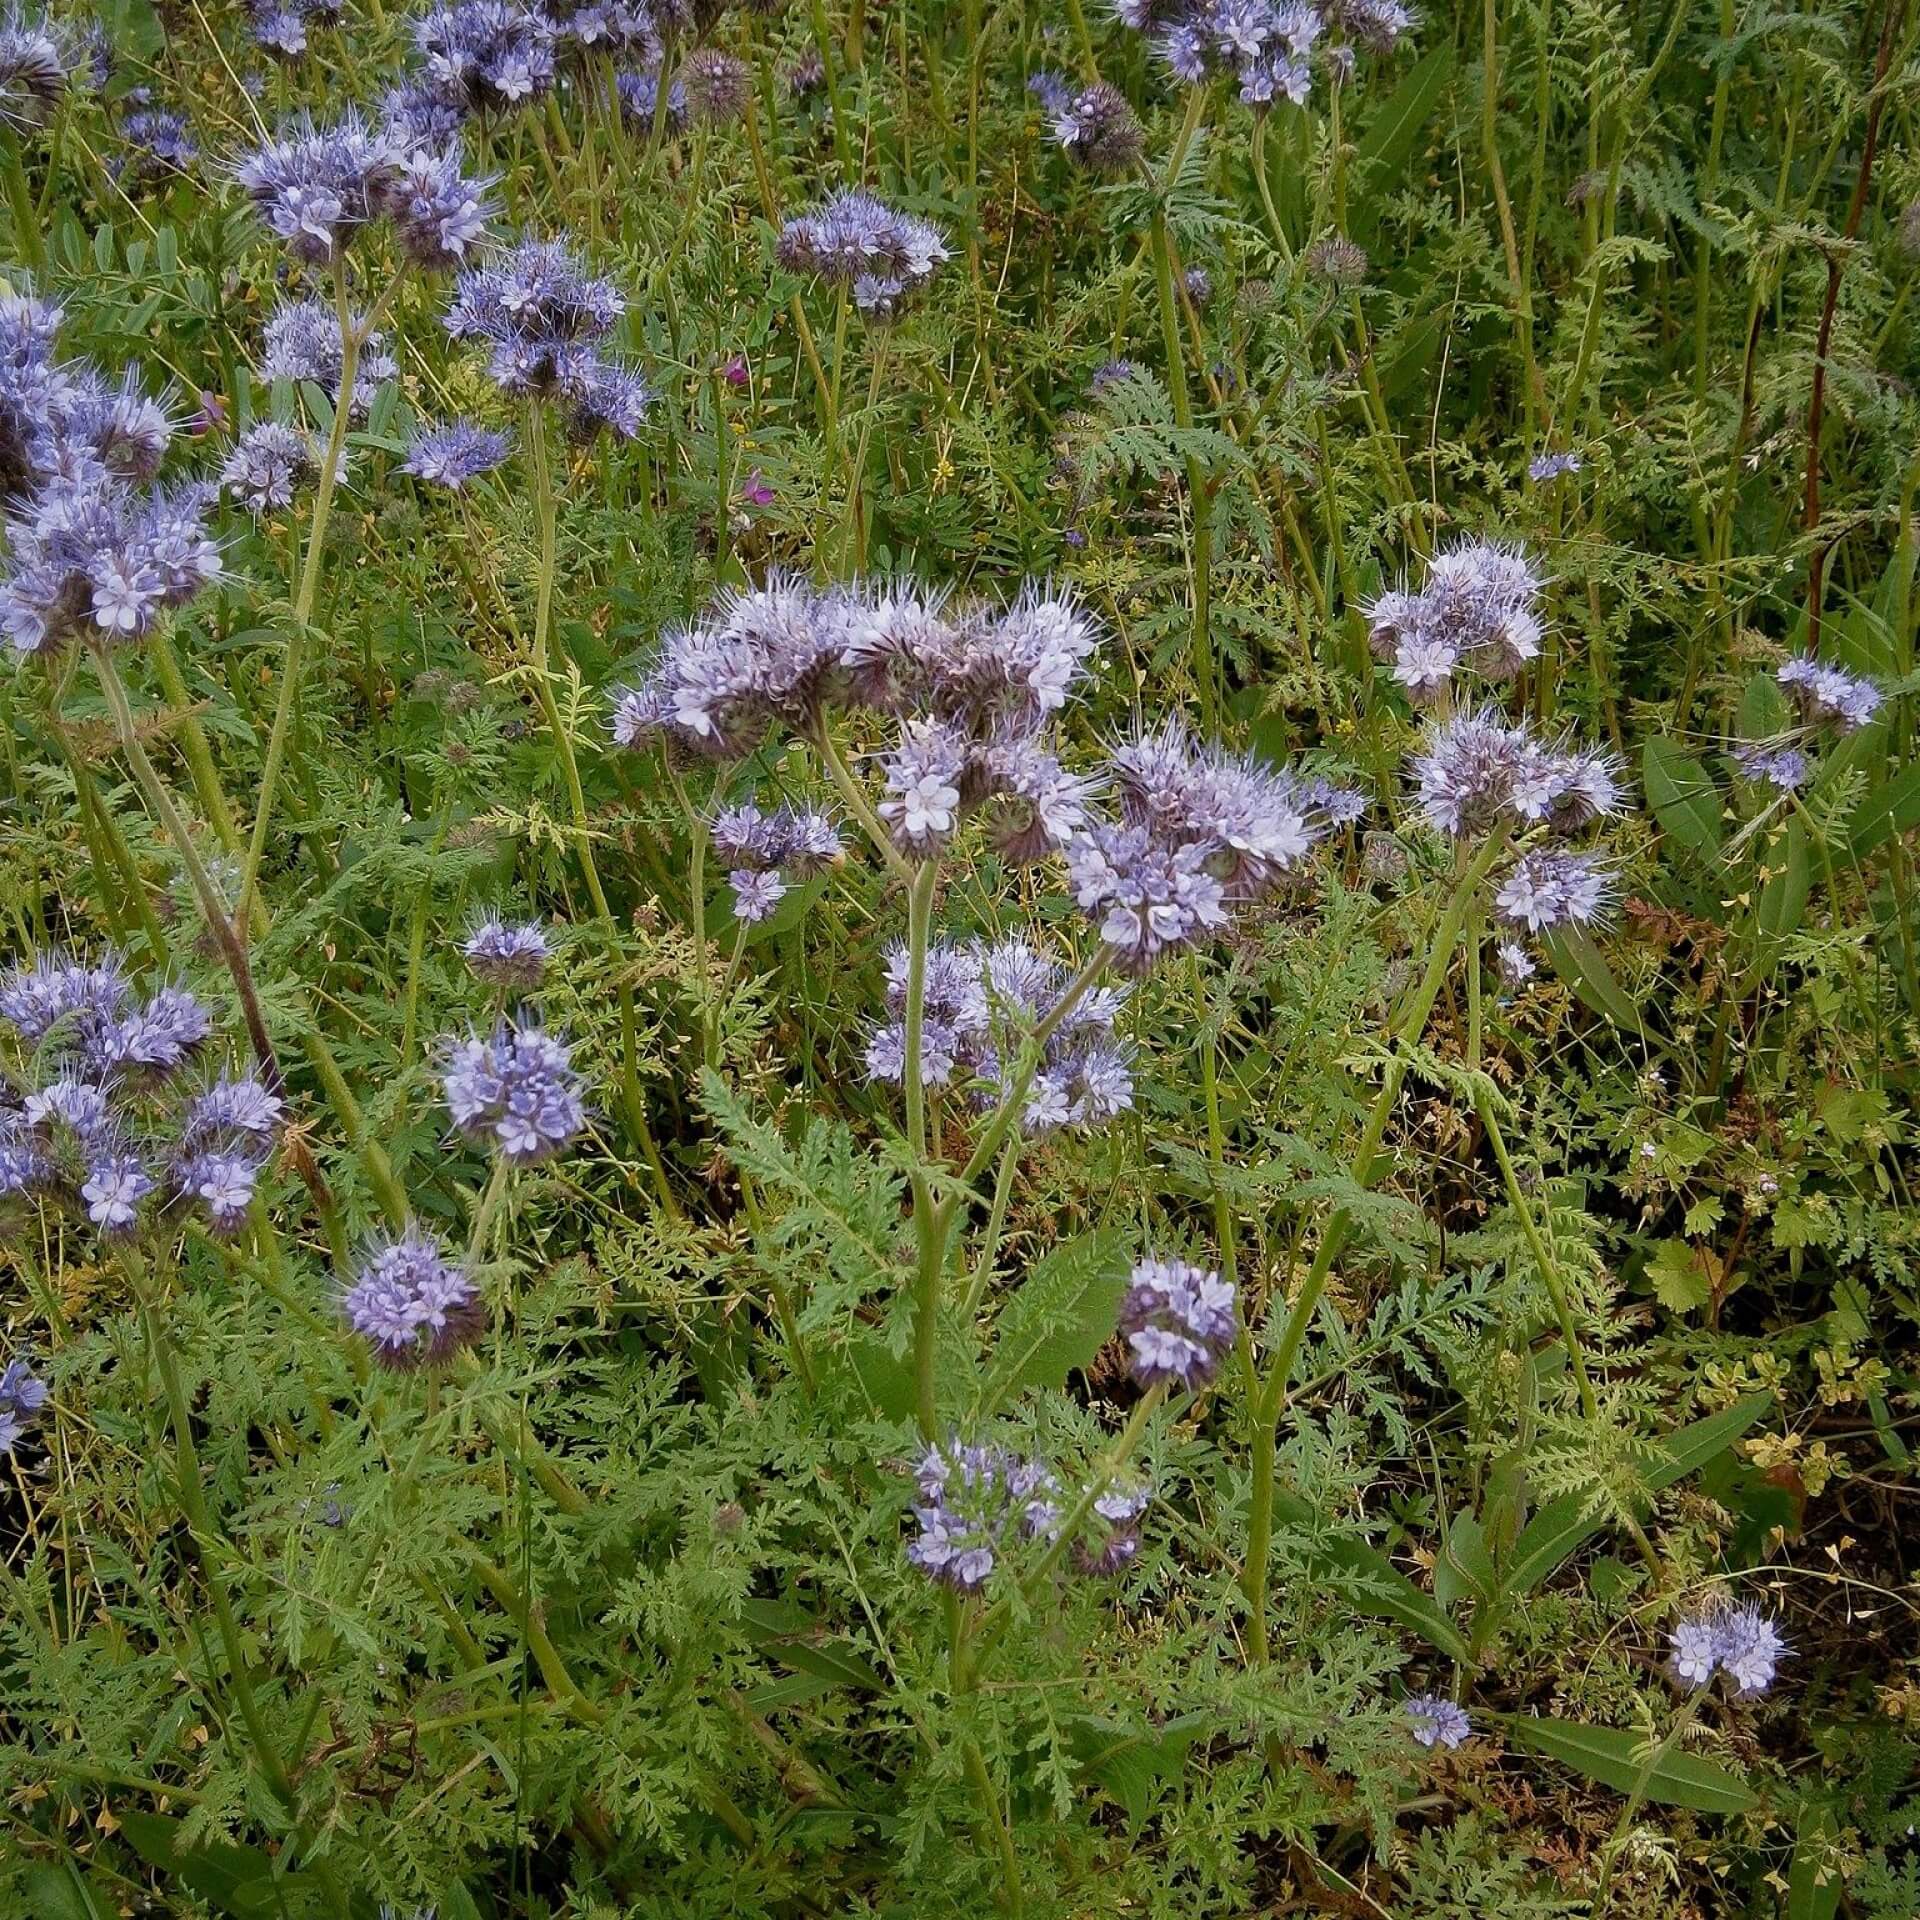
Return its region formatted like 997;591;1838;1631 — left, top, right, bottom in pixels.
447;240;653;440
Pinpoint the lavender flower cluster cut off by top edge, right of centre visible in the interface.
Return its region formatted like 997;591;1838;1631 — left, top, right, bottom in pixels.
1114;0;1411;108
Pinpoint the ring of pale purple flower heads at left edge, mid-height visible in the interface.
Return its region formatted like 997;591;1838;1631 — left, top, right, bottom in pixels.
0;952;282;1235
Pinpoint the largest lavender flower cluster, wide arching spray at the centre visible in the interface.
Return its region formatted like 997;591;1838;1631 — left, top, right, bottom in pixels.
612;576;1365;973
